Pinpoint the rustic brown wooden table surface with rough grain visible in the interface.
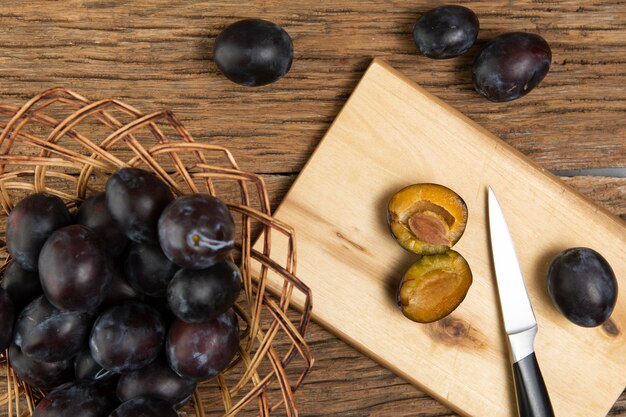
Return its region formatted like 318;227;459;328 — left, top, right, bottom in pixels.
0;0;626;417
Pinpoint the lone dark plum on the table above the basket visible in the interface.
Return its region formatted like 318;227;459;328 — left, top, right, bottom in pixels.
213;19;293;87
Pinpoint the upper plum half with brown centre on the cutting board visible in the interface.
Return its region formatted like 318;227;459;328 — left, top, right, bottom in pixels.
387;183;467;255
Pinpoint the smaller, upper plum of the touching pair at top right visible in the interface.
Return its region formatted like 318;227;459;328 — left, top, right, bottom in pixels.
413;6;479;59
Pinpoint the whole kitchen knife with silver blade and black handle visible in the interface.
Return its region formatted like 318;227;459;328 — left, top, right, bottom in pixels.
488;187;554;417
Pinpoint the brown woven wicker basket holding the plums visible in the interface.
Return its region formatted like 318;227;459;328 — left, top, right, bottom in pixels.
0;88;313;417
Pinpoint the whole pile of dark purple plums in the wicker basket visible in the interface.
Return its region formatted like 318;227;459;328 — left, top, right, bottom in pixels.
0;168;242;417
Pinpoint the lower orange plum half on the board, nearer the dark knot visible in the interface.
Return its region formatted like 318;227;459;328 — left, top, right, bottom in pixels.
398;250;472;323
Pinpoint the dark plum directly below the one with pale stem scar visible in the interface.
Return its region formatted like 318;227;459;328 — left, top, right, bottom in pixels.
167;261;241;323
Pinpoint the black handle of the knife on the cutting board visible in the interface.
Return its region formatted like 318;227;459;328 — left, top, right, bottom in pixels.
513;353;554;417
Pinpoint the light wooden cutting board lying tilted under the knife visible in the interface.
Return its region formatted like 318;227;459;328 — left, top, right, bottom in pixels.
251;60;626;417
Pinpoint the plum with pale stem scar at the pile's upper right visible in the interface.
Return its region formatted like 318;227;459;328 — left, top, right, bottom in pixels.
159;194;235;269
